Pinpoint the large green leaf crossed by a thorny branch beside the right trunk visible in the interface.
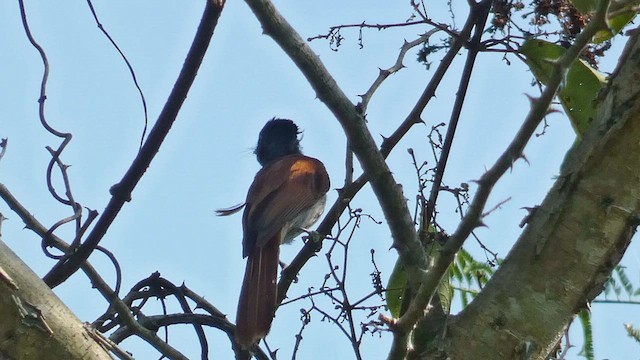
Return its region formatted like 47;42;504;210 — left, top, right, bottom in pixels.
520;39;606;137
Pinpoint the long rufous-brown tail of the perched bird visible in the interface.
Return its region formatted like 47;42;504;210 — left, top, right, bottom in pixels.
235;238;280;349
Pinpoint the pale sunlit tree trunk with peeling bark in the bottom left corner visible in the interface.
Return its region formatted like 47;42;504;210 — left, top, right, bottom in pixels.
0;241;111;360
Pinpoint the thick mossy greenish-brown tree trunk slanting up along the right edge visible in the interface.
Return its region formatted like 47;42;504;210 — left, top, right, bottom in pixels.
438;31;640;359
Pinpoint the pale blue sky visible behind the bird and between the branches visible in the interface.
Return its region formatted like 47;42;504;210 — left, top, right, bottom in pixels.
0;1;640;359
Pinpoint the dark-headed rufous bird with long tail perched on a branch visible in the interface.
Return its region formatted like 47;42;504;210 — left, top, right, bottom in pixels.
217;118;330;350
